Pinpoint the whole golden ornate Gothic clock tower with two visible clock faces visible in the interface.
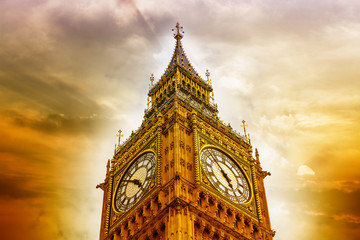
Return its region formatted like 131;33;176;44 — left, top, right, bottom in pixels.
98;24;275;240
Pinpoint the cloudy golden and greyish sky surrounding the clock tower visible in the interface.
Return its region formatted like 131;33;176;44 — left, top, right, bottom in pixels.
0;0;360;240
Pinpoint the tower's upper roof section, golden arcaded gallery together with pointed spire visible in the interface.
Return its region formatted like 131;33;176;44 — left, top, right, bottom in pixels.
145;23;218;122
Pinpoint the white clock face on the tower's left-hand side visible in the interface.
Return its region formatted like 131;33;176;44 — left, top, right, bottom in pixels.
114;152;156;212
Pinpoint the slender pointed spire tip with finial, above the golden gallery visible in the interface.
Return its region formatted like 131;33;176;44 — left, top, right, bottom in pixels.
164;23;200;77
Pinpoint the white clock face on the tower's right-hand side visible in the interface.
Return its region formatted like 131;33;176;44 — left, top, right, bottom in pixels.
200;148;250;203
